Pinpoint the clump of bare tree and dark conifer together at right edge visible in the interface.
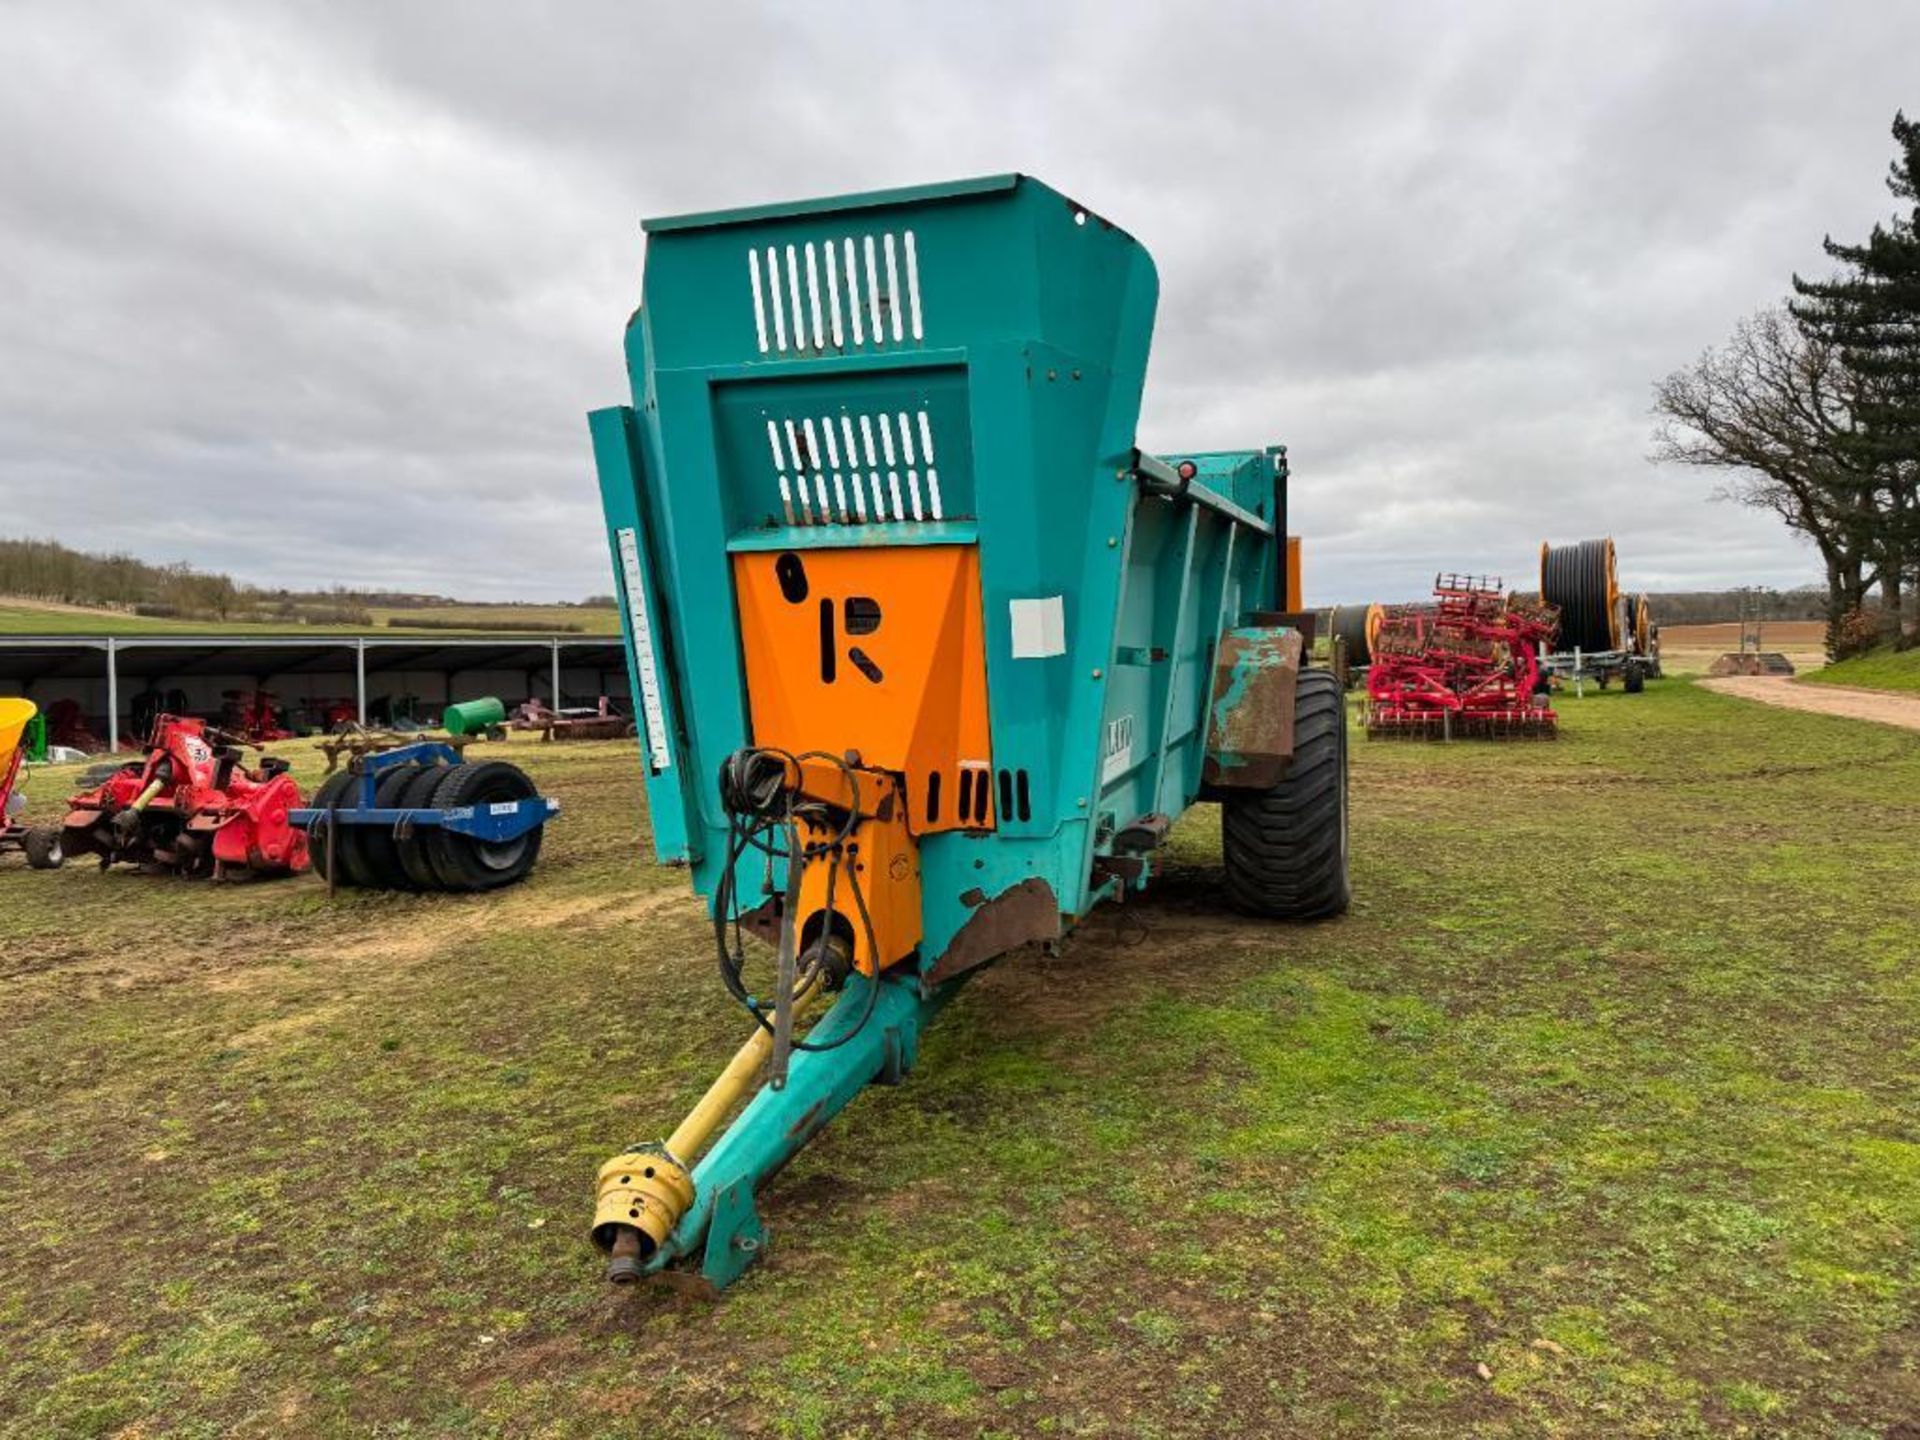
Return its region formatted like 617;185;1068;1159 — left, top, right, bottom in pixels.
1655;113;1920;657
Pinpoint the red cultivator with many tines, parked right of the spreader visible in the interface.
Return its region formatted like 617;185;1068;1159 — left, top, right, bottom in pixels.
1367;574;1559;739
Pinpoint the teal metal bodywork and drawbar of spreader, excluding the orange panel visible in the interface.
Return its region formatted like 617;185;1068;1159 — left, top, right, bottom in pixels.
589;175;1284;1283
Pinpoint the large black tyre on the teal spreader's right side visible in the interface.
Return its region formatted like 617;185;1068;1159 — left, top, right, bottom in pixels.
1221;670;1352;920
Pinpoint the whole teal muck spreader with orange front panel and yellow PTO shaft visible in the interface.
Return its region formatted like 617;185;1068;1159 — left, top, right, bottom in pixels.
591;175;1348;1286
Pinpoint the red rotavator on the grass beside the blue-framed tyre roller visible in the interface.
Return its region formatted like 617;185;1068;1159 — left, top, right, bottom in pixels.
63;714;307;877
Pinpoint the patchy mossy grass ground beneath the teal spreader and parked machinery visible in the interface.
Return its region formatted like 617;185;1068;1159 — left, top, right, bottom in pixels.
0;682;1920;1440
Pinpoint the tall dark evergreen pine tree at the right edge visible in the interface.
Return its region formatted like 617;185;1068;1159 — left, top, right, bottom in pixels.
1791;113;1920;636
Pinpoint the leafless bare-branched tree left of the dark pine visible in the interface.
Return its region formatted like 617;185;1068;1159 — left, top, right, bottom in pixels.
1653;309;1899;648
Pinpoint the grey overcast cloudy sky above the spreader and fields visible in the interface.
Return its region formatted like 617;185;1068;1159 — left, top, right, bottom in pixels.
0;0;1920;603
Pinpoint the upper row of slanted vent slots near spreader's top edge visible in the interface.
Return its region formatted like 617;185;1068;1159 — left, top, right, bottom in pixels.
747;230;925;355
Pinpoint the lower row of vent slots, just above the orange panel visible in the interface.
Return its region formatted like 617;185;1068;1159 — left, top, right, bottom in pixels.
766;409;945;524
